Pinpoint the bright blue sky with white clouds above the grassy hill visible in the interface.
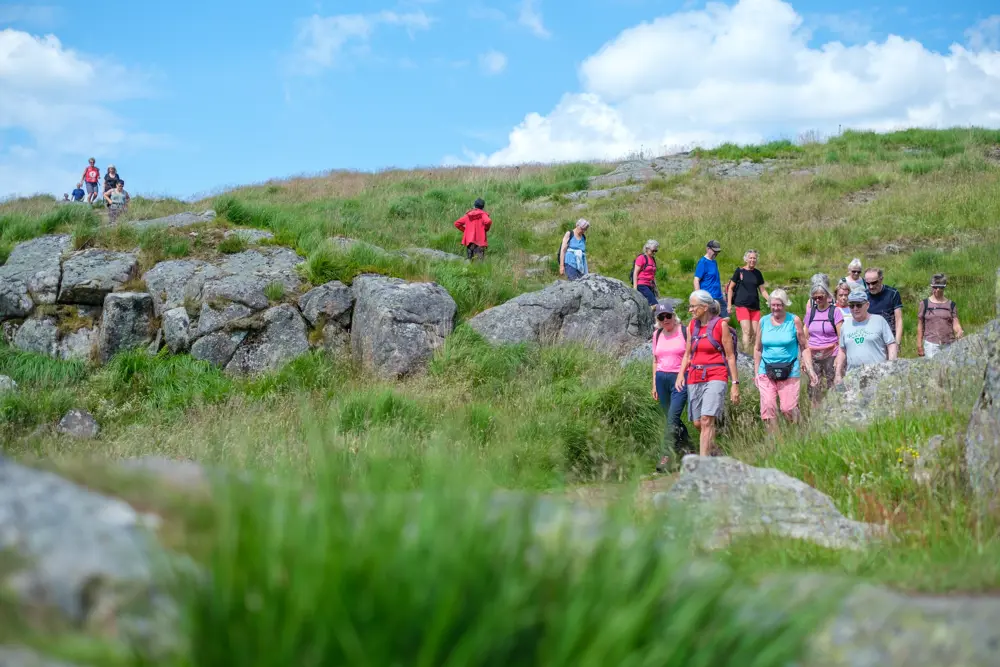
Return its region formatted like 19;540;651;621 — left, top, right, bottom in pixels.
0;0;1000;197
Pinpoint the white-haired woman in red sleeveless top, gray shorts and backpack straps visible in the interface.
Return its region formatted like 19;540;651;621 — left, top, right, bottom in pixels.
674;290;740;456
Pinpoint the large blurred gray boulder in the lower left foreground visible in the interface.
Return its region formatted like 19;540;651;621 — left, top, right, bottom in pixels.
0;456;176;643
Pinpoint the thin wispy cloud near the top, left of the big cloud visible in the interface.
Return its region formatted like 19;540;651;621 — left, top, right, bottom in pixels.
290;10;433;74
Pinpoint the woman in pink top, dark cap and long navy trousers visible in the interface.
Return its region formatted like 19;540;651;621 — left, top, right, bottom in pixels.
653;303;691;472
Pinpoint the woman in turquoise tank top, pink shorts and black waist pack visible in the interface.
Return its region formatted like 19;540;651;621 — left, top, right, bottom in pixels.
753;289;819;433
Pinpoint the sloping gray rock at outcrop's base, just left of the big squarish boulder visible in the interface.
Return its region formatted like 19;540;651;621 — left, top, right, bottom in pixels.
226;304;309;375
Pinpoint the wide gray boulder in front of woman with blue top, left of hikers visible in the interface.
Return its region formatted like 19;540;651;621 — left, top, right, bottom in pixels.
469;274;653;355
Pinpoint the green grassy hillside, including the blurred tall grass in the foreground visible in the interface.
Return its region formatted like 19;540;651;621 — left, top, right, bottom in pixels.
0;130;1000;665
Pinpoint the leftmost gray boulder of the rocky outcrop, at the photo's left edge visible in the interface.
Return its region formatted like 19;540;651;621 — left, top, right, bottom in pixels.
0;234;73;320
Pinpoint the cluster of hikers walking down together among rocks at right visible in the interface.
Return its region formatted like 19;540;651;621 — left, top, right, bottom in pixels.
633;241;964;472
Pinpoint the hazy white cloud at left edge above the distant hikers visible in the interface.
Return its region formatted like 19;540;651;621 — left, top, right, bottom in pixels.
0;29;158;196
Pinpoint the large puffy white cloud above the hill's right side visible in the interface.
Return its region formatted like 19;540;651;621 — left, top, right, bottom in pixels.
476;0;1000;164
